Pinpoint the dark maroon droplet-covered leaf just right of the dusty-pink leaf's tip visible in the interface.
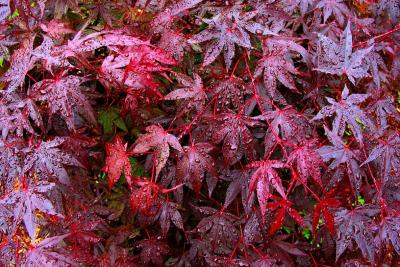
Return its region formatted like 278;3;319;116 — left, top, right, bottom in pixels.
176;143;217;193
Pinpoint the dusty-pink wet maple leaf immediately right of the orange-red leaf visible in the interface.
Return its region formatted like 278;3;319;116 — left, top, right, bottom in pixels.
131;125;182;177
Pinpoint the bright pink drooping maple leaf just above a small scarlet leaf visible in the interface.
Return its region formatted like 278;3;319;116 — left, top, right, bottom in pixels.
247;160;286;219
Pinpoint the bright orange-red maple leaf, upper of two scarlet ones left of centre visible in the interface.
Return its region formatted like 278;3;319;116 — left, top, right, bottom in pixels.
103;136;133;190
